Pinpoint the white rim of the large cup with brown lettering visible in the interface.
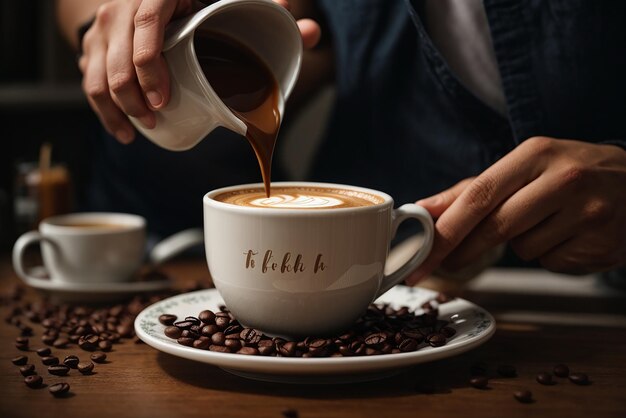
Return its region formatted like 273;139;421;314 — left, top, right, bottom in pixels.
202;181;394;217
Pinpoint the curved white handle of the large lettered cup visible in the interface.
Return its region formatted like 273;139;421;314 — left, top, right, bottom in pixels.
376;203;435;297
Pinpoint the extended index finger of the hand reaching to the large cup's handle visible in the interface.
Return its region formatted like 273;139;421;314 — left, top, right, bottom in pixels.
413;142;542;280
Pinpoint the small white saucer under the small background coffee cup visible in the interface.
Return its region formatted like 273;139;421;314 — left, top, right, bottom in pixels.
24;267;172;302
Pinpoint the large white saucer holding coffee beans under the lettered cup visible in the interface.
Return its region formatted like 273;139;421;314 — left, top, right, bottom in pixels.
135;286;496;383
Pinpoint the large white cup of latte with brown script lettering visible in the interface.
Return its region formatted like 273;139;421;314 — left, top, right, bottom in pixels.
203;182;434;338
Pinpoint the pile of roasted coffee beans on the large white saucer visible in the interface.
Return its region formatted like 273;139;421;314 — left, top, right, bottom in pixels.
159;296;456;357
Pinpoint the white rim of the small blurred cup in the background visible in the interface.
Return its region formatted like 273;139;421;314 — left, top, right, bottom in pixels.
39;212;146;235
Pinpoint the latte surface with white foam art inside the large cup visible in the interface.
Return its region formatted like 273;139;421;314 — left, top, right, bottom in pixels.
215;186;384;209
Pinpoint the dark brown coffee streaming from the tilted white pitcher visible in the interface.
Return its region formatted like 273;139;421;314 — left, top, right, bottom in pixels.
194;29;281;197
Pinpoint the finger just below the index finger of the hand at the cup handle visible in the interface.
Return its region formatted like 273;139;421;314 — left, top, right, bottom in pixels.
443;175;563;271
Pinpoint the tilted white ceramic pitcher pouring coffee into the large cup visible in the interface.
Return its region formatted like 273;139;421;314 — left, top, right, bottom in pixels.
130;0;302;151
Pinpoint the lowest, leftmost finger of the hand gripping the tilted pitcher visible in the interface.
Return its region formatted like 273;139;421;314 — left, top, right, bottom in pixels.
83;43;135;144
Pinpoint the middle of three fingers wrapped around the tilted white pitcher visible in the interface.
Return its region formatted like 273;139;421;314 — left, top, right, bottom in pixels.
106;16;156;129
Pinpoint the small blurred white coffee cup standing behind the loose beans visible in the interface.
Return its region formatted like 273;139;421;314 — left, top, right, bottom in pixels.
13;213;146;284
